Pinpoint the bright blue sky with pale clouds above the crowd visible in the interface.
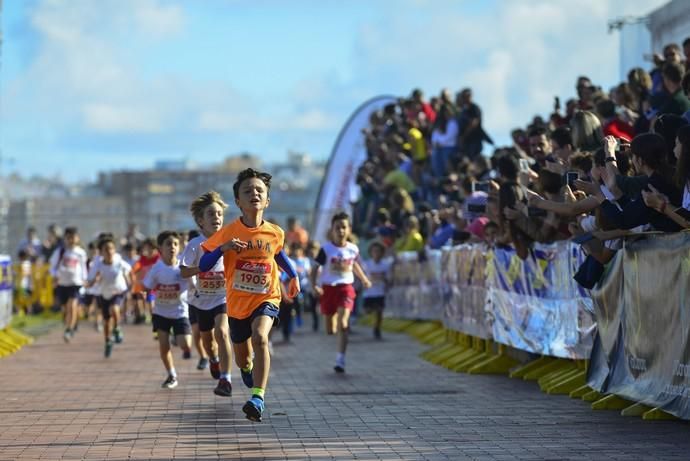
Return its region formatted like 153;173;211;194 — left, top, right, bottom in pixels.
0;0;664;181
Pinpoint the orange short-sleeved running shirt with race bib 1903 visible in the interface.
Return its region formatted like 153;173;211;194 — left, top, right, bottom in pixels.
201;218;285;320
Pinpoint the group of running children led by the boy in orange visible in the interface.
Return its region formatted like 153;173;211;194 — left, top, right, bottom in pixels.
51;168;390;421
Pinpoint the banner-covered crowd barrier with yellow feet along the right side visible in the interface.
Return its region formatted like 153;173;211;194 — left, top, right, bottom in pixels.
370;234;690;419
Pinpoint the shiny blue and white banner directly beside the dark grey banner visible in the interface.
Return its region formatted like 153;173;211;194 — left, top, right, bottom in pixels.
486;242;596;359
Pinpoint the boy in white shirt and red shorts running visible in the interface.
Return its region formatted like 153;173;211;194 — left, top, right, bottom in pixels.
312;213;371;373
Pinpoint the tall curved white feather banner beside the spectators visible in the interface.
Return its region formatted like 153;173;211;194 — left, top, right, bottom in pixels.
311;96;397;241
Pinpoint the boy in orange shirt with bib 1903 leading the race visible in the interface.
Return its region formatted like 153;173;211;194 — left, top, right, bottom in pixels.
199;168;300;422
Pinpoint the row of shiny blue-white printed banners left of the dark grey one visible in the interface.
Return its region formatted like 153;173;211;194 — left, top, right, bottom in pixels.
386;242;596;359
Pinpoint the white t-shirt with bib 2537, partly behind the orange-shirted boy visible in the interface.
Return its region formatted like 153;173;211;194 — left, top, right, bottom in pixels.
180;235;226;311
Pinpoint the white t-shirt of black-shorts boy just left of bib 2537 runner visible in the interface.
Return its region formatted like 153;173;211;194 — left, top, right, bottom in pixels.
144;259;189;319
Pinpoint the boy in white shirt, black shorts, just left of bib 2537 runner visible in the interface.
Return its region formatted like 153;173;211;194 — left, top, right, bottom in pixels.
144;231;192;389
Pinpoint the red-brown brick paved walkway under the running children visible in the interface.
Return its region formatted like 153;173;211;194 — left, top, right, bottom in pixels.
0;316;690;460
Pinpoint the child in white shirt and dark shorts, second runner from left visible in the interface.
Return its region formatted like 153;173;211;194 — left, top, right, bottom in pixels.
87;236;132;358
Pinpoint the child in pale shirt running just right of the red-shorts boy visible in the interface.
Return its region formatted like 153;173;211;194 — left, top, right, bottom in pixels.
362;241;391;339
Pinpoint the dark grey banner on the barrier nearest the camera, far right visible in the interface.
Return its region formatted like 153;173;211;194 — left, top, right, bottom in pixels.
588;233;690;419
